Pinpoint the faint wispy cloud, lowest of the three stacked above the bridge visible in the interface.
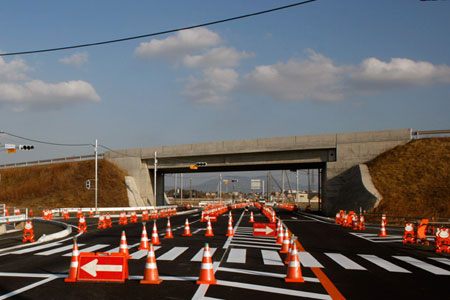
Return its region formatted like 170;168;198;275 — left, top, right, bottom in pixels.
182;68;239;104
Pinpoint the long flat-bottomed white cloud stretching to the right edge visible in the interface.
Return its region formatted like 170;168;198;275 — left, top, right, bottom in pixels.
244;51;450;101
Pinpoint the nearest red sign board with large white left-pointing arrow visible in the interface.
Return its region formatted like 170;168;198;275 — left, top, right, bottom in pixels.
77;252;128;282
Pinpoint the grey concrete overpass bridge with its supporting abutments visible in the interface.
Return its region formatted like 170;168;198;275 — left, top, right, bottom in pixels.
104;129;412;214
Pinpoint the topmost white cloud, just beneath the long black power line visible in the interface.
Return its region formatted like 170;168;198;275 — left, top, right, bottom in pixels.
134;28;220;60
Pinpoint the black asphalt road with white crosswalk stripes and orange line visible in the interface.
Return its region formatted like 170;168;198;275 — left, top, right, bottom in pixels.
0;208;450;299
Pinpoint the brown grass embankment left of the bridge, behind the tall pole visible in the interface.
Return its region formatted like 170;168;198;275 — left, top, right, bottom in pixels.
0;160;128;215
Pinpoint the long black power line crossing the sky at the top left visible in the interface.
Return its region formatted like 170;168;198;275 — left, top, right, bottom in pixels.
0;0;316;56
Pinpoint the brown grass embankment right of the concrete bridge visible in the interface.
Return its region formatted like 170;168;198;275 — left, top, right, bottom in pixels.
367;138;450;218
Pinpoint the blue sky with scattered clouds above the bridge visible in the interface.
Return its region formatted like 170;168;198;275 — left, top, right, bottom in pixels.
0;0;450;164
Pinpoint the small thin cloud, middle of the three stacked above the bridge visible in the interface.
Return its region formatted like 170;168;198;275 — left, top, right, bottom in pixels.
183;47;252;68
